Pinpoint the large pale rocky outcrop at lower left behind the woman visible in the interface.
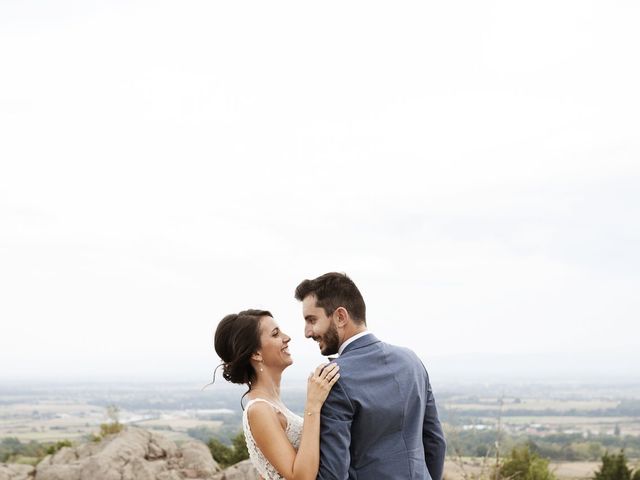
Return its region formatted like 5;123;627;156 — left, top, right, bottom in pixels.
0;428;258;480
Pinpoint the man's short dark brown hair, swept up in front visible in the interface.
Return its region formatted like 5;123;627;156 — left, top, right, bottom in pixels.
295;272;367;325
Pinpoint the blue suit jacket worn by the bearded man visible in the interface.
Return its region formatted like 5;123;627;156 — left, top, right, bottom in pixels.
318;334;446;480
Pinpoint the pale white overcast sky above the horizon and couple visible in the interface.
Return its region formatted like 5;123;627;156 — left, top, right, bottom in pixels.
0;0;640;380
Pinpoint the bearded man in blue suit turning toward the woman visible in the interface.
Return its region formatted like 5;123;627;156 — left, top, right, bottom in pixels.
295;272;446;480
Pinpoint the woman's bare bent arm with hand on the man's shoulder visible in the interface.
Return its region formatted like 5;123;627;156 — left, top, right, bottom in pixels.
247;363;340;480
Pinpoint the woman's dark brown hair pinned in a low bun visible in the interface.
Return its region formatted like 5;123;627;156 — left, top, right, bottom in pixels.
213;310;273;402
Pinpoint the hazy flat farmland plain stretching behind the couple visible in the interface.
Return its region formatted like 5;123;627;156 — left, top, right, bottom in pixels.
0;384;640;480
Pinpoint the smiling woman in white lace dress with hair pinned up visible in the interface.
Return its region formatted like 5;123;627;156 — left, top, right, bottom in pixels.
214;310;340;480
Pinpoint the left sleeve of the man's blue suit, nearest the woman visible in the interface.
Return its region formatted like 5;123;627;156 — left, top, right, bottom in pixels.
317;380;354;480
